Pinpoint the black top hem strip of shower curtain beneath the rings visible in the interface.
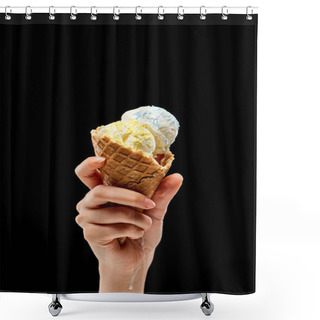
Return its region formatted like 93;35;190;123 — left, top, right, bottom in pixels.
0;13;258;26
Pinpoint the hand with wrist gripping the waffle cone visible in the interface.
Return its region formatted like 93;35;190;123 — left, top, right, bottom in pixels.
75;157;183;293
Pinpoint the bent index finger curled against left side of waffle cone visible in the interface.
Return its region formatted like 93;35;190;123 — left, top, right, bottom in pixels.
75;157;105;189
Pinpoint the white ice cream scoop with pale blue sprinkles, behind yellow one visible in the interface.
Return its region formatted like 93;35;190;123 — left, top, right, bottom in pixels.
121;106;180;155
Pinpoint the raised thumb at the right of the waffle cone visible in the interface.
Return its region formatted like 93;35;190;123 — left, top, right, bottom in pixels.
145;173;183;220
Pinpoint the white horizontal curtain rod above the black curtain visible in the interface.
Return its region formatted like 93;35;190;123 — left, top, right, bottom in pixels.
0;6;258;15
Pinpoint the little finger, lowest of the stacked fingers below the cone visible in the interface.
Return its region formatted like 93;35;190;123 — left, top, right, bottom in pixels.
83;223;144;245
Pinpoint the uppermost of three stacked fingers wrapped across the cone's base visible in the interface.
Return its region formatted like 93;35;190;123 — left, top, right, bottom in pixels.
83;185;155;209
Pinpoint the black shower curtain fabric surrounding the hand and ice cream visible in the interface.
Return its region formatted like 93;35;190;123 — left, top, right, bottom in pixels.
0;14;258;294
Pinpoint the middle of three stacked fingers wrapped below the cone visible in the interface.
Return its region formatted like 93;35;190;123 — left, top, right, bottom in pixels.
76;203;152;230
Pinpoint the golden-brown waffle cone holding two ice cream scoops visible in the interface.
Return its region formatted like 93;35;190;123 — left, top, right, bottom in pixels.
91;127;174;244
